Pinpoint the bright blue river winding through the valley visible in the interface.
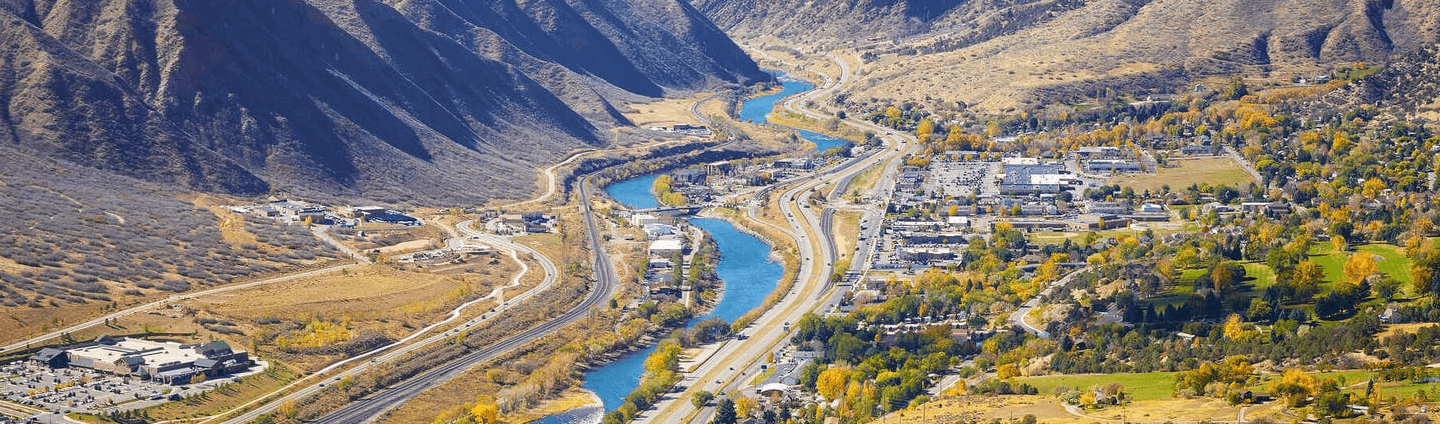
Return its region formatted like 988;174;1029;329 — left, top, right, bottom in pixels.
531;74;823;424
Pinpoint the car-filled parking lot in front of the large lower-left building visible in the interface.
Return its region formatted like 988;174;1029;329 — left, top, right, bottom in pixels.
0;362;249;414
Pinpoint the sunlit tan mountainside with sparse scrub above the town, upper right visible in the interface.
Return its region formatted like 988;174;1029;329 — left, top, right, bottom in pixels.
696;0;1440;111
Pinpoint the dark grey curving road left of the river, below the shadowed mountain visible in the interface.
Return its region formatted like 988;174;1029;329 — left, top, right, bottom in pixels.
300;180;618;424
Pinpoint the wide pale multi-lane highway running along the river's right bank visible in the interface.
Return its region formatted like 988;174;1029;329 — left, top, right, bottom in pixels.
636;52;916;424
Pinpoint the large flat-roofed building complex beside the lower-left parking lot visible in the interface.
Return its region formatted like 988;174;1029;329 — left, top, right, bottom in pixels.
30;336;255;385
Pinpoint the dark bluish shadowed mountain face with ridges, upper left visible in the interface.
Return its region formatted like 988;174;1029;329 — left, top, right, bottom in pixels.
0;0;765;203
